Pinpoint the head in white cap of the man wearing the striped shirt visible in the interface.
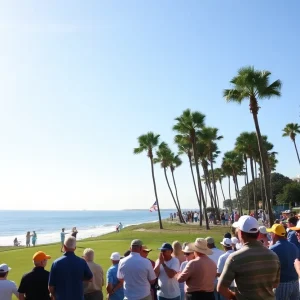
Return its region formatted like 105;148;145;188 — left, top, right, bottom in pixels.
232;216;259;244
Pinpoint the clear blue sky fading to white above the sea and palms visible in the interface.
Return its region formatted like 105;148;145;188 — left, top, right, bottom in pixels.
0;0;300;210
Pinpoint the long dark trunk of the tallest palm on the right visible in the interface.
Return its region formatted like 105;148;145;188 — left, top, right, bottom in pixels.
250;112;274;226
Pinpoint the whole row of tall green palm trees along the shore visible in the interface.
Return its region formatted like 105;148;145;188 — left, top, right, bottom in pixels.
134;67;300;229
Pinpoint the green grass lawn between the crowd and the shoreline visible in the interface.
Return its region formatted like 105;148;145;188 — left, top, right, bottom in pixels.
0;222;230;298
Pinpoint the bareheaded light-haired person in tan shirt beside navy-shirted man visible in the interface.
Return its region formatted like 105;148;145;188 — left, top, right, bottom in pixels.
83;248;104;300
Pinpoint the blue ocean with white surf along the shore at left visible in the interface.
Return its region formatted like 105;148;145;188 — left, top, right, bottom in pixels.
0;210;174;246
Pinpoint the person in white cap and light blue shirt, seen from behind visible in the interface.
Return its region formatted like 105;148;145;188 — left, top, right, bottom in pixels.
106;252;124;300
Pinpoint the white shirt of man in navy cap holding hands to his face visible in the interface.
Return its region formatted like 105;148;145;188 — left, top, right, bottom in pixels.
156;257;180;298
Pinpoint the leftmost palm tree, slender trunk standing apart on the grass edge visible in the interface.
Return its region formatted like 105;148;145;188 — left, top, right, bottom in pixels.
133;132;163;229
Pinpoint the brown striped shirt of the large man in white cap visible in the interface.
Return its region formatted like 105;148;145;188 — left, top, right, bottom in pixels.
219;241;280;300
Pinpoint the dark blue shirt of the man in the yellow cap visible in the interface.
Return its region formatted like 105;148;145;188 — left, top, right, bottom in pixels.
270;240;299;283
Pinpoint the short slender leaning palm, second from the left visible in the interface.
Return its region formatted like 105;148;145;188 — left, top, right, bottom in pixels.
153;142;184;223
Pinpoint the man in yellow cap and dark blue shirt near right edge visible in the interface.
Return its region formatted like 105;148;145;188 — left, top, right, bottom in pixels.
267;224;300;300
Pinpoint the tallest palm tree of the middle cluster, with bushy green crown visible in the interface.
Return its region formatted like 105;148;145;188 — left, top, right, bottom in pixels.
173;109;209;229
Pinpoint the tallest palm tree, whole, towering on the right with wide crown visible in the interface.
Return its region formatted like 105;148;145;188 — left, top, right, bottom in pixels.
223;66;281;225
